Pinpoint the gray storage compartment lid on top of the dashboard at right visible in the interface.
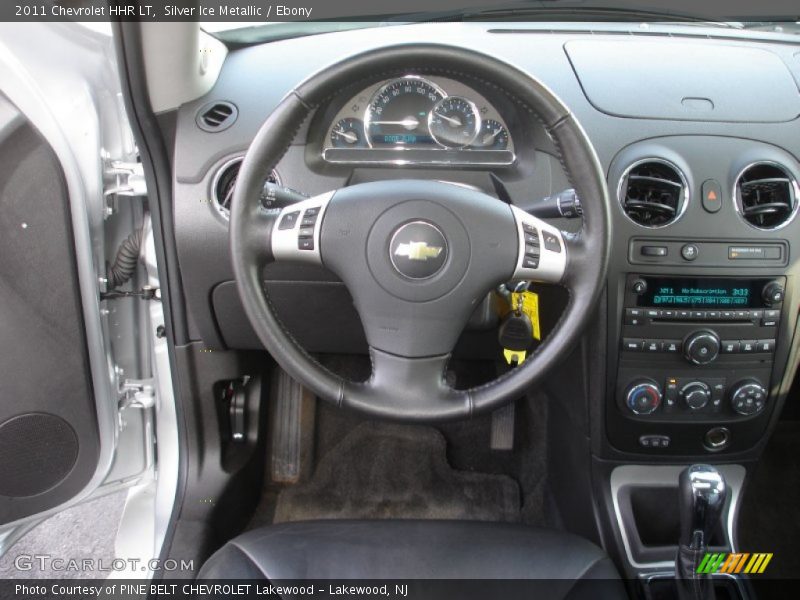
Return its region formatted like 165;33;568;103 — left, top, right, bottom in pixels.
565;40;800;123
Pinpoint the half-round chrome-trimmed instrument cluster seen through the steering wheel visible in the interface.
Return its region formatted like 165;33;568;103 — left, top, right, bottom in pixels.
323;75;515;165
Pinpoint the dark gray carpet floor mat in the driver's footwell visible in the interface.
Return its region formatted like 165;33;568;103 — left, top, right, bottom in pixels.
274;422;520;523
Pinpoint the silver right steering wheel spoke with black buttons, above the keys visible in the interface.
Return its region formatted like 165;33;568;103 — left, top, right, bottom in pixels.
511;206;570;283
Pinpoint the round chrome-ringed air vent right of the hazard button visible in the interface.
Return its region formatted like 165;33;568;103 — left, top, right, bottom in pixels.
736;163;797;229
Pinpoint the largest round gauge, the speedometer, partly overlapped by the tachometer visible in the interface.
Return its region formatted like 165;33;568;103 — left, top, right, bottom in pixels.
364;77;446;147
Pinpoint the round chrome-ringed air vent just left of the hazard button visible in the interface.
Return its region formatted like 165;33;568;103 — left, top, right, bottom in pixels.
619;159;688;227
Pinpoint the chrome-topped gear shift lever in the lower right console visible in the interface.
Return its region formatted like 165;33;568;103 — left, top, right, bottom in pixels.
675;465;728;600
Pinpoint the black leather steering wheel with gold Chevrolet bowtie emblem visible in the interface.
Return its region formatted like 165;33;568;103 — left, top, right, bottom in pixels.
230;44;610;421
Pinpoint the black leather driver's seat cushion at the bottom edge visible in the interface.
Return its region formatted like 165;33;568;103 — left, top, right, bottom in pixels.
199;521;627;599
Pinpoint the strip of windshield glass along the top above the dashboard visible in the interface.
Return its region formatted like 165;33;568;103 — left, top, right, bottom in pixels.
201;0;800;45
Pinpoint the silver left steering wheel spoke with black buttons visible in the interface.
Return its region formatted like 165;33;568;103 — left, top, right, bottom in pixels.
269;191;336;265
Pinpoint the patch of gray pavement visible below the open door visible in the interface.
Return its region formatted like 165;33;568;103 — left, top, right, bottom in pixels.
0;491;127;579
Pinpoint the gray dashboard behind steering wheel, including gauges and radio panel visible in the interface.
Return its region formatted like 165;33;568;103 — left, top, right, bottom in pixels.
174;23;800;460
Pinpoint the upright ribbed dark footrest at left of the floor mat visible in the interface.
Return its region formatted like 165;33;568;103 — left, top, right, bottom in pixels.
270;368;316;483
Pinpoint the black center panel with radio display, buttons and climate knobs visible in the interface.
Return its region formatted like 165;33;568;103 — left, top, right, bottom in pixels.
609;273;786;455
